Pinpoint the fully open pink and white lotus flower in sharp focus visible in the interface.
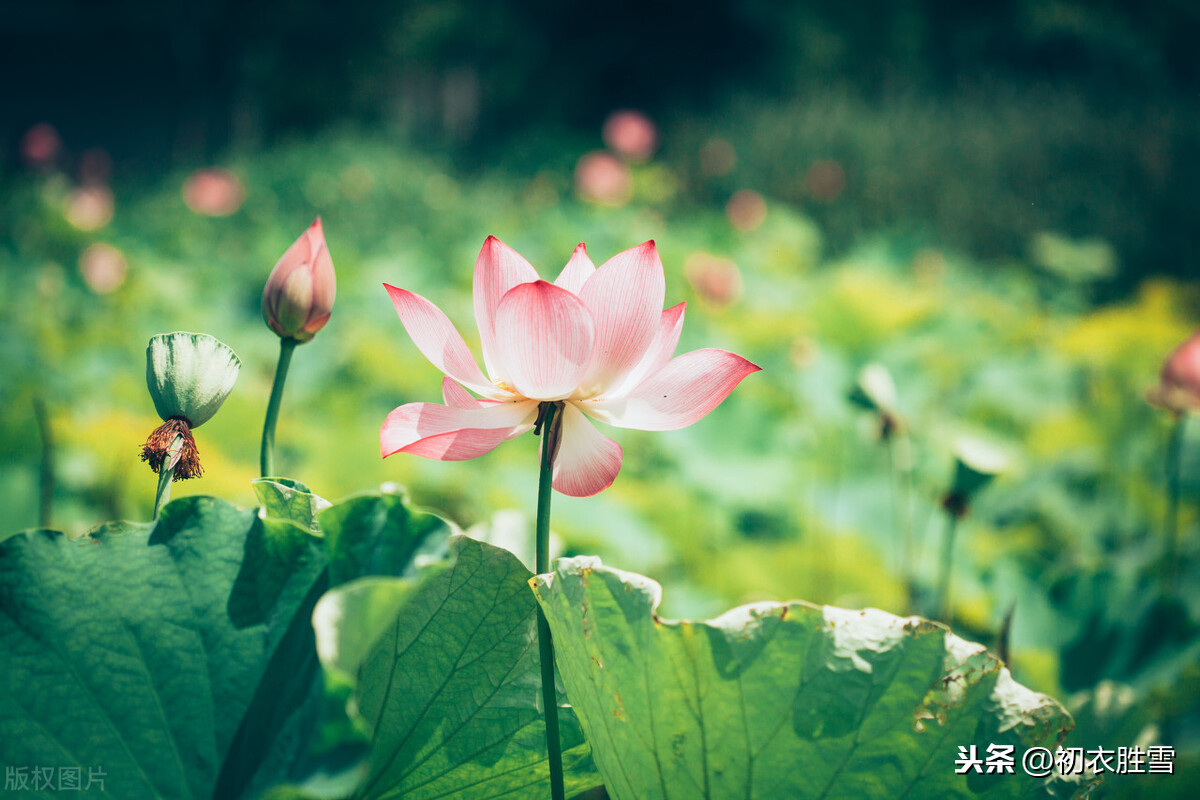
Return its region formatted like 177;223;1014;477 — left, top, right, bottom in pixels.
379;236;758;497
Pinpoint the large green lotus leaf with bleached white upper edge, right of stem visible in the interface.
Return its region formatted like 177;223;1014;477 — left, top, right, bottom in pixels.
535;558;1094;800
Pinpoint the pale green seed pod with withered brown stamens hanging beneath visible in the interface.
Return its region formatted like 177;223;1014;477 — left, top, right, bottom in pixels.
142;331;241;480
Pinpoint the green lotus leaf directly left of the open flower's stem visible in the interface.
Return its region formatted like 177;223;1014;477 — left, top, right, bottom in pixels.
313;534;599;800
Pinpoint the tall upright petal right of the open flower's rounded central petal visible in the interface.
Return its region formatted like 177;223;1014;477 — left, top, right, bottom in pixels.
580;241;666;393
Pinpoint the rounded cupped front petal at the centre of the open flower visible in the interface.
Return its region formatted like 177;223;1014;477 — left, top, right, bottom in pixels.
496;281;594;401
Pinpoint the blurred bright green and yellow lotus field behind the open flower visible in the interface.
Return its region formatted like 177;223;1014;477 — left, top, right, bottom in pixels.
0;130;1200;789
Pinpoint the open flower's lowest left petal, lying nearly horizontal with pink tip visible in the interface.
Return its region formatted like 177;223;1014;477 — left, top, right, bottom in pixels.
379;401;538;461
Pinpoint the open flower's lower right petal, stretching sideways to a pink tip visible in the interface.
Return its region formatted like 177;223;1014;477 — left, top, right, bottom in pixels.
580;349;761;431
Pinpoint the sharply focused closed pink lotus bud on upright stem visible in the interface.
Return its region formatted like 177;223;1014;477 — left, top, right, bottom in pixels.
263;217;337;344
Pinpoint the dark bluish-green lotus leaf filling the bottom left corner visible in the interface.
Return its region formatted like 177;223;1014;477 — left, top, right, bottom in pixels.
0;497;320;800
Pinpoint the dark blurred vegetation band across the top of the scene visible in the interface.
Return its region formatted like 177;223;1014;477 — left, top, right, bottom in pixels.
0;0;1200;281
